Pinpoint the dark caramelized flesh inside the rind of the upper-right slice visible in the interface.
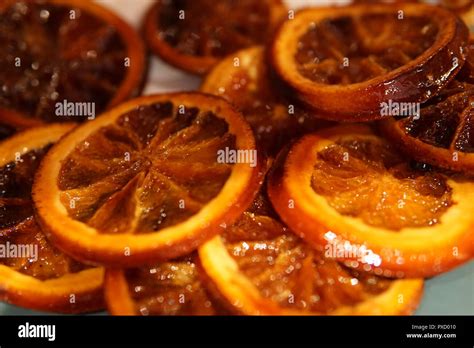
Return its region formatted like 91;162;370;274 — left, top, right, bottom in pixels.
295;12;438;85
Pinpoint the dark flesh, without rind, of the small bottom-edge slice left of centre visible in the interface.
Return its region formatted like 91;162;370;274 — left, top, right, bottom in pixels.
125;257;217;315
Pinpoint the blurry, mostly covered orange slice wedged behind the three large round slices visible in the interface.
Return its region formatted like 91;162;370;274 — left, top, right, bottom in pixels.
200;46;328;156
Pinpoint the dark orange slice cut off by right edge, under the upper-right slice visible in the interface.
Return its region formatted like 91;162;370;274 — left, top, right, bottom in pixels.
380;40;474;173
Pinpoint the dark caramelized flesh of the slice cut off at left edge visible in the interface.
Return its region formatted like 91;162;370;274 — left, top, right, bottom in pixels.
0;145;86;280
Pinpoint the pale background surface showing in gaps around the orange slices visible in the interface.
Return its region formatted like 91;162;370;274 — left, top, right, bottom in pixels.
0;0;474;315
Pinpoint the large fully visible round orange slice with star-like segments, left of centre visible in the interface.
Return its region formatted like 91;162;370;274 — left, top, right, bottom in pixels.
33;93;262;267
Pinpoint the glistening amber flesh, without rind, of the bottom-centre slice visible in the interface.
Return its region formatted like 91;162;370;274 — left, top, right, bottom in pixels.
223;196;390;314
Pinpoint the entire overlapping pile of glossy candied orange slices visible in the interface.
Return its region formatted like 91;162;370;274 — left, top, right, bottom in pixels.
0;0;474;316
